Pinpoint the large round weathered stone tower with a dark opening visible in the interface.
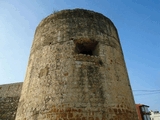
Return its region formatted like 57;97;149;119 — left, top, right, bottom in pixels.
16;9;137;120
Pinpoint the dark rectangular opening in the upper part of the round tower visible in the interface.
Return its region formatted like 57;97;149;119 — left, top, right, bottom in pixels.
75;39;98;55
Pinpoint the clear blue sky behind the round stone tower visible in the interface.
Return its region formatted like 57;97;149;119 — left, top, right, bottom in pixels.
0;0;160;110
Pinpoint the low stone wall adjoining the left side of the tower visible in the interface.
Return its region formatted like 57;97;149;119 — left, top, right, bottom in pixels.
0;83;22;120
